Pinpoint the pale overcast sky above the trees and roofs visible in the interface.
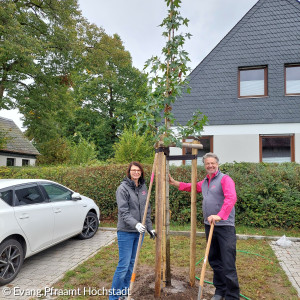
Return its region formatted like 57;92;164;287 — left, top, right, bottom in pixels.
0;0;258;130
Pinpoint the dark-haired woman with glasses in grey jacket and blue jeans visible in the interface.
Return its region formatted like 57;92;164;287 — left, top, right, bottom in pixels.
109;162;156;300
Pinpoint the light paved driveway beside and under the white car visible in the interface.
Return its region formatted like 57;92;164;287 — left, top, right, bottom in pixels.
0;230;117;300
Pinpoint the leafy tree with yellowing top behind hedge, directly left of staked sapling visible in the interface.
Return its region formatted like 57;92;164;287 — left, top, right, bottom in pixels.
69;28;147;160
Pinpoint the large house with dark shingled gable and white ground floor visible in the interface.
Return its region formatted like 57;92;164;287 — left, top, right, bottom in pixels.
171;0;300;163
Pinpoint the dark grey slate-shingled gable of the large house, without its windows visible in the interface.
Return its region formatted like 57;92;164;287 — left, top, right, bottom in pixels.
173;0;300;125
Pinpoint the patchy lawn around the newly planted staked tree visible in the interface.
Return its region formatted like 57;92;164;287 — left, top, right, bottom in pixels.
55;236;298;300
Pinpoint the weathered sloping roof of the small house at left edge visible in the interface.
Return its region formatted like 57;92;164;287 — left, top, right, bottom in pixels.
0;117;40;155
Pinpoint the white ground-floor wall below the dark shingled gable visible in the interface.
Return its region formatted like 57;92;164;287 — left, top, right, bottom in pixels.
170;123;300;165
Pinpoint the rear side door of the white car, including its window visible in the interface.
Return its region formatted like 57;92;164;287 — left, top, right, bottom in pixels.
14;183;54;252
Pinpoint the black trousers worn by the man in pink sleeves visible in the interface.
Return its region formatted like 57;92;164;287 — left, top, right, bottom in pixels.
205;225;240;300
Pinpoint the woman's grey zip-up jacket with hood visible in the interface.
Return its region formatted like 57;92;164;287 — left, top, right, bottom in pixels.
116;178;153;232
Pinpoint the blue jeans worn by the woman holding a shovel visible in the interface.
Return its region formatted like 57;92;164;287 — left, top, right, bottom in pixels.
109;231;144;300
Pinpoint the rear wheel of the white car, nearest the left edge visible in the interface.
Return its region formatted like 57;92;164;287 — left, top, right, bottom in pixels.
0;239;24;285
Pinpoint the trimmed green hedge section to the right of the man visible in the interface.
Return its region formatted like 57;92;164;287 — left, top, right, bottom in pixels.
221;163;300;228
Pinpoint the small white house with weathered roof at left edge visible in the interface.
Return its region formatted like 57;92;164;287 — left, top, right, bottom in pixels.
0;117;40;166
